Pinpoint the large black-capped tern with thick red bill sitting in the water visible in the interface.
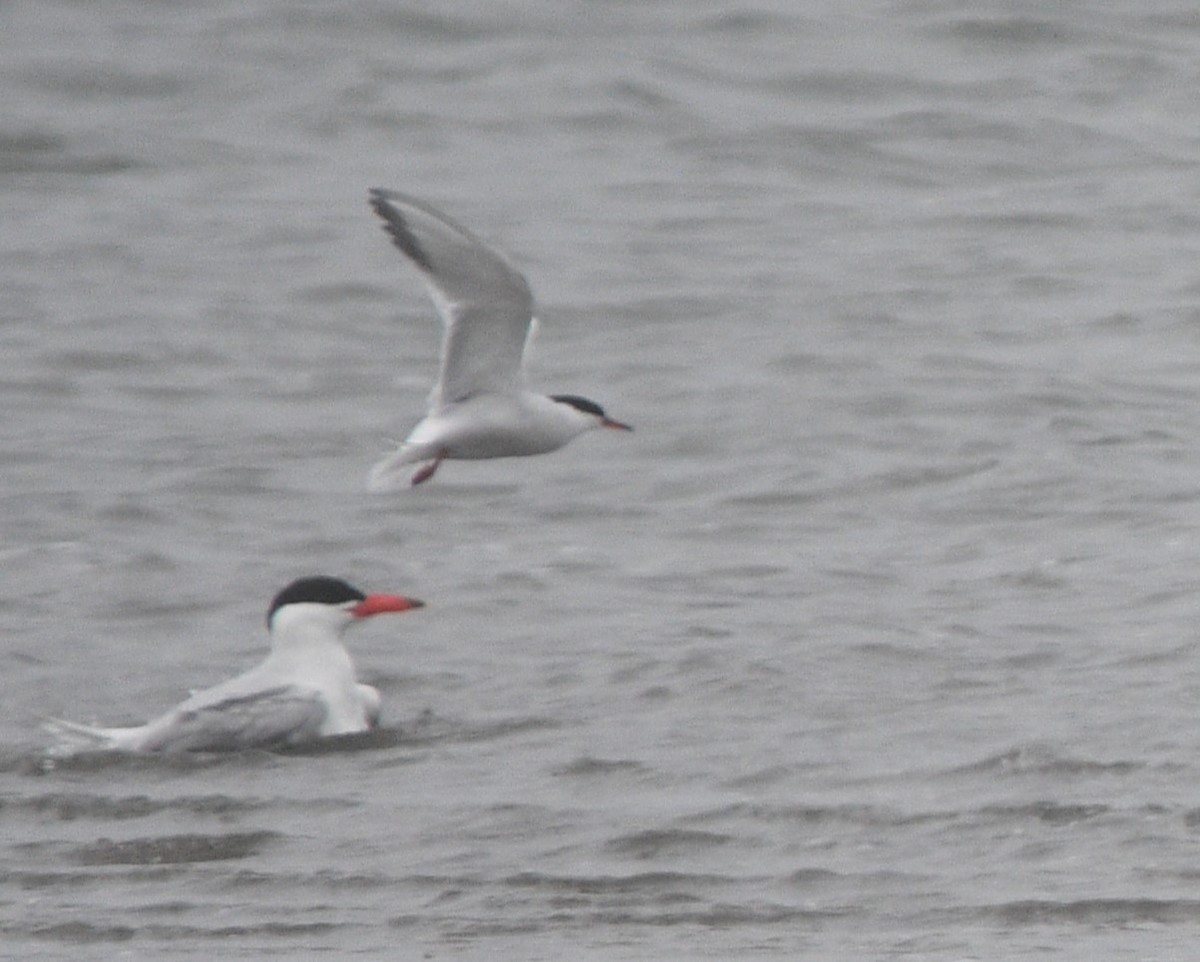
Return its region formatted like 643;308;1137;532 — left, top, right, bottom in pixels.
46;576;422;753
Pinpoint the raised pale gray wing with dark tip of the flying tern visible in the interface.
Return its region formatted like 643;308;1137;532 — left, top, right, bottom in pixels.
371;188;533;409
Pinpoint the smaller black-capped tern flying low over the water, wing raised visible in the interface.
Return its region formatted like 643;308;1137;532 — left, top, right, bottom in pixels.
367;188;631;491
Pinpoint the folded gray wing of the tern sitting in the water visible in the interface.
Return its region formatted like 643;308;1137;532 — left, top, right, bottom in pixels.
142;685;326;752
